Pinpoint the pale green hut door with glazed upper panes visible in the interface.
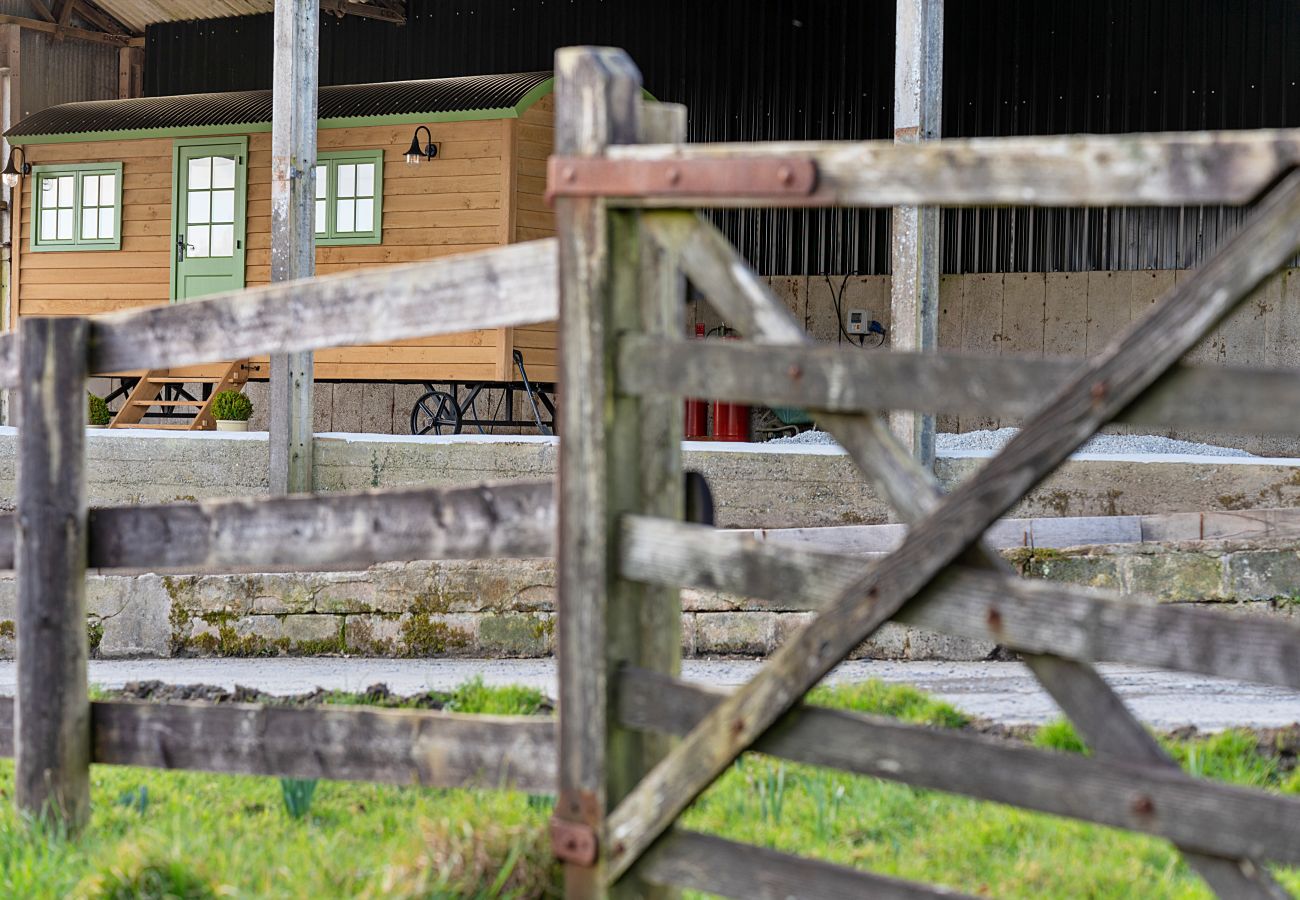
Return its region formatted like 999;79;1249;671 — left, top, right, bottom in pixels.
172;138;248;300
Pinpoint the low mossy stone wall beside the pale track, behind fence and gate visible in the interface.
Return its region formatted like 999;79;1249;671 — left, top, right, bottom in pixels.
0;533;1300;659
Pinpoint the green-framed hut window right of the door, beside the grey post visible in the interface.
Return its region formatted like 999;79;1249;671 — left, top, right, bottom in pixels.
316;150;384;247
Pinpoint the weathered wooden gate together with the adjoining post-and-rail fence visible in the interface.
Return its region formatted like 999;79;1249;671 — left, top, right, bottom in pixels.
0;42;1300;897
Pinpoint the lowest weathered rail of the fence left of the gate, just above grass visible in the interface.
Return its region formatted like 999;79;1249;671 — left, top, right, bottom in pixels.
0;697;555;793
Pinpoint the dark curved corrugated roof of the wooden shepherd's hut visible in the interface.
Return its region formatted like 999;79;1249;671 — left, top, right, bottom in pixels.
5;72;551;138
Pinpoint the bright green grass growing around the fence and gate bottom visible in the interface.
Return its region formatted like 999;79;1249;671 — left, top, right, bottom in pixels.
0;682;1300;899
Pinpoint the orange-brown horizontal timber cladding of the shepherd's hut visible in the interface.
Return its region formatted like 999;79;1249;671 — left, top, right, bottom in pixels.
14;112;555;381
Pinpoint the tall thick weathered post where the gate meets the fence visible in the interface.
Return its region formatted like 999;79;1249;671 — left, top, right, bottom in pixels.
553;47;683;897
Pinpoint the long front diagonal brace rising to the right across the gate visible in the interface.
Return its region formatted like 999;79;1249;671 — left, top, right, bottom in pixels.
608;173;1300;873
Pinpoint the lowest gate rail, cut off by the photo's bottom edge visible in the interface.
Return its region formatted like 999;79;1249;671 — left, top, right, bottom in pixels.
636;828;967;900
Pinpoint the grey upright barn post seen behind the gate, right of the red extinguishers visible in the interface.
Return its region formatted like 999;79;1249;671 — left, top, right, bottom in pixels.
889;0;944;468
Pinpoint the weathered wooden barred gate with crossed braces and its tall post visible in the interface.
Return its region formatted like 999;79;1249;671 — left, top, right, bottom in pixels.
549;42;1300;897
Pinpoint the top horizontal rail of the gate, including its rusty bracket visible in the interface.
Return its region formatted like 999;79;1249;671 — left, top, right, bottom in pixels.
549;129;1300;208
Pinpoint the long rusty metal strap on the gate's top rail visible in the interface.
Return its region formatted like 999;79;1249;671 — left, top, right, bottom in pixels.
546;156;818;203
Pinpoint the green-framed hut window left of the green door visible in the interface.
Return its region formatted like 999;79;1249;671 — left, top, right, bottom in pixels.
31;163;122;251
